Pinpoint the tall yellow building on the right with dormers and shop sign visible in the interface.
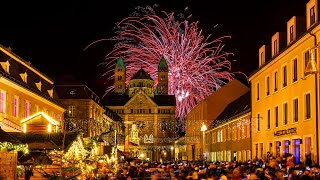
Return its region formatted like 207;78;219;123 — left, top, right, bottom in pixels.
249;0;320;163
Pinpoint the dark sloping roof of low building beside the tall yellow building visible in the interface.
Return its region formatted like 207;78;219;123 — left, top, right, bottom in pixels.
210;91;251;128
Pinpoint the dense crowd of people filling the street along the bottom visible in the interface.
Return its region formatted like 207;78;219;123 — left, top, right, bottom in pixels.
94;156;320;180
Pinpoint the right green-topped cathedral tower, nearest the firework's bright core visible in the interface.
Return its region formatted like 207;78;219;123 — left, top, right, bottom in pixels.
157;57;169;94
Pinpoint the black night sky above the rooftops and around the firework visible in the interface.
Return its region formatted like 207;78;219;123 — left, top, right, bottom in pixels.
0;0;308;95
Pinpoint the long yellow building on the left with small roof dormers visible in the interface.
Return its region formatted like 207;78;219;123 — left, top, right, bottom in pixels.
0;45;65;133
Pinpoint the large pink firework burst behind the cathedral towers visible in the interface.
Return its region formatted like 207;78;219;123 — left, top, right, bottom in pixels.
89;12;239;119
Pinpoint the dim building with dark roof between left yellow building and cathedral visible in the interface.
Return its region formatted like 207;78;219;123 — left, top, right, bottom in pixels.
55;82;123;138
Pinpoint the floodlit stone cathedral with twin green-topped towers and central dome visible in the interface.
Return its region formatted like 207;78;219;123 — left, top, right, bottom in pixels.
105;57;177;161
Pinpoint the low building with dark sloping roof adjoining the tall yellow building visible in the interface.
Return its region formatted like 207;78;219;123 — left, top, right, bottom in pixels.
204;91;251;162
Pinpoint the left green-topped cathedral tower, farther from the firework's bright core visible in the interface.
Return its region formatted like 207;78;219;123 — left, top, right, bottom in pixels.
114;56;126;94
